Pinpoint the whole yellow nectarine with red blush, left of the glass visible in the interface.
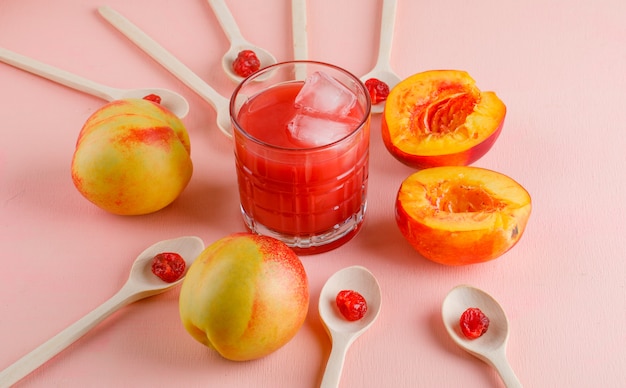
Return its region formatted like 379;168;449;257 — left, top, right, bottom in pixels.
72;99;193;215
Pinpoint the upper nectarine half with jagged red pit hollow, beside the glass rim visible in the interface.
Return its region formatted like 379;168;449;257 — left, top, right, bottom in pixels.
381;70;506;169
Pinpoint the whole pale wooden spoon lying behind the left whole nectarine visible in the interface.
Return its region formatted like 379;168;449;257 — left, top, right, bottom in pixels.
0;48;189;118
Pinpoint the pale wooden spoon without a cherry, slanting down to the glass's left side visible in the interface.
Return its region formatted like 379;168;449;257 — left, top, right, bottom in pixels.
98;6;233;138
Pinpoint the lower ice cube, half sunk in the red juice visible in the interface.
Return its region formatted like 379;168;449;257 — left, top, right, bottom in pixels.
287;113;359;147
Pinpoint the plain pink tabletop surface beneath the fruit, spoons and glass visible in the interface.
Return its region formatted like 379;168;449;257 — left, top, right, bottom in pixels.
0;0;626;387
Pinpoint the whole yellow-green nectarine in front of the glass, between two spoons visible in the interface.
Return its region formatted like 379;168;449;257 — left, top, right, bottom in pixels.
179;233;309;361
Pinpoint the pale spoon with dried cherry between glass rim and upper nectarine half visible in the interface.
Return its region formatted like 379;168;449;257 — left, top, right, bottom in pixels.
361;0;402;113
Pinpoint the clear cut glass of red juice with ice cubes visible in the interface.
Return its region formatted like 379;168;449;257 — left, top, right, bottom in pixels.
231;62;370;254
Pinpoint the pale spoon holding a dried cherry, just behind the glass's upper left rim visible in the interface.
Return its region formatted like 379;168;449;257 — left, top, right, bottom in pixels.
208;0;276;83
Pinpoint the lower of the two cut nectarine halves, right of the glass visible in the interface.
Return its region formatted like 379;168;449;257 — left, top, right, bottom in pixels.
395;166;531;265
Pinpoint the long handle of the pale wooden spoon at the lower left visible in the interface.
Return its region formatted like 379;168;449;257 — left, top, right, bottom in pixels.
0;282;143;388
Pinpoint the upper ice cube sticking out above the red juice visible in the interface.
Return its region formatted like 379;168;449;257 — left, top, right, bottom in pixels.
295;71;356;117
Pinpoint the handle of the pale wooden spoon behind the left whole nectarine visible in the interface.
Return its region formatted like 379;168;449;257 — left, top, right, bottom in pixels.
0;47;122;101
